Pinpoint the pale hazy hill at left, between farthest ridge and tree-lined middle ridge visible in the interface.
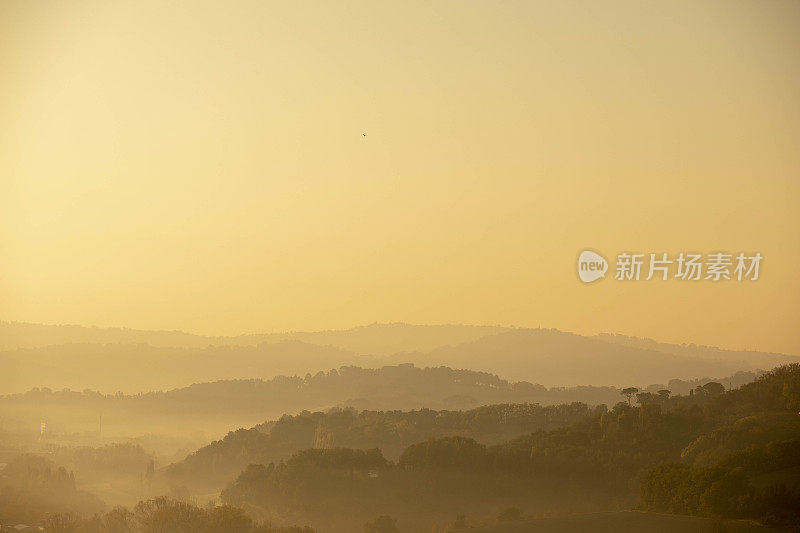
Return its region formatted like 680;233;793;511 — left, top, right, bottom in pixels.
0;341;362;393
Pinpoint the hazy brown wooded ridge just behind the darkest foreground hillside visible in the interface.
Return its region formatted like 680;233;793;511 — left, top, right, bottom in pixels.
165;403;591;486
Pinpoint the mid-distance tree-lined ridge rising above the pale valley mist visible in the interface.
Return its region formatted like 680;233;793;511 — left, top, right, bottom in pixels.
0;364;756;442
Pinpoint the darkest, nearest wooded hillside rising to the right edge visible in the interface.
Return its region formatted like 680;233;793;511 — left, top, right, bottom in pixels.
223;365;800;531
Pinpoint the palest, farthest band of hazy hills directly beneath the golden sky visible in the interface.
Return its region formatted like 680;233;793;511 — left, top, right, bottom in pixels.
0;322;800;393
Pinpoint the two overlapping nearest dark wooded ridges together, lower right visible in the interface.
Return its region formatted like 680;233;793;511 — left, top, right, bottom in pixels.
209;364;800;533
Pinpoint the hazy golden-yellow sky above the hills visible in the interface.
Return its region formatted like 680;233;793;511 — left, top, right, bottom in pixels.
0;0;800;353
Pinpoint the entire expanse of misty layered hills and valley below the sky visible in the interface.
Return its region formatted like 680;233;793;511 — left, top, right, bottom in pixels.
0;324;800;533
